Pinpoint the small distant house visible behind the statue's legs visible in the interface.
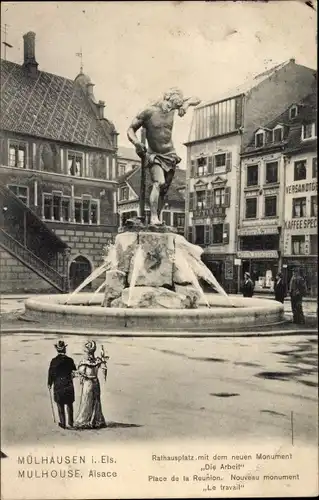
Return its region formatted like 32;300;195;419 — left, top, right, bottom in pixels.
117;159;186;234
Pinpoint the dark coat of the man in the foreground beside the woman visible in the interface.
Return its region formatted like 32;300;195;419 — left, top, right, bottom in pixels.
48;354;76;404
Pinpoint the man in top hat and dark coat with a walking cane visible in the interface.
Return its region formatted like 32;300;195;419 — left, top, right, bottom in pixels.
48;340;76;429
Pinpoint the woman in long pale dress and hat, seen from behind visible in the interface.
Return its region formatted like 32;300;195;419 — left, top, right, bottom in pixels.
74;340;108;429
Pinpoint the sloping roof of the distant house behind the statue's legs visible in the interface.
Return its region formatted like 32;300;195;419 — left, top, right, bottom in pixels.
118;166;186;205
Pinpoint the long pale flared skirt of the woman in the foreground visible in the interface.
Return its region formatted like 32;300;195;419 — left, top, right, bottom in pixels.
74;378;106;429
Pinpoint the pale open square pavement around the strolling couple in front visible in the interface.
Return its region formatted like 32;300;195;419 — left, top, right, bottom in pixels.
1;334;318;453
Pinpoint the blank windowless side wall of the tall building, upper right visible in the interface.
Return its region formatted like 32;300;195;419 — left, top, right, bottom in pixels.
242;62;315;148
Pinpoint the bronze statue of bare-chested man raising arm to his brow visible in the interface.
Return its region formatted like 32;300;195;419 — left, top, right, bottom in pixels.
127;88;201;225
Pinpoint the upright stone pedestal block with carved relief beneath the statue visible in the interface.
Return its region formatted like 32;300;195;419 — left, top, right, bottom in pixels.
127;232;175;287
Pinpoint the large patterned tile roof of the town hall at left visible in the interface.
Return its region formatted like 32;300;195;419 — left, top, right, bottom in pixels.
1;60;116;149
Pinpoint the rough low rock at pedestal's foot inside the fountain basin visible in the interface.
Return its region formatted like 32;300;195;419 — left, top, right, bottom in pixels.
111;286;192;309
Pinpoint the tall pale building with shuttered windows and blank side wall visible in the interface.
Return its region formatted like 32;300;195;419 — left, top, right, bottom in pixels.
185;60;315;292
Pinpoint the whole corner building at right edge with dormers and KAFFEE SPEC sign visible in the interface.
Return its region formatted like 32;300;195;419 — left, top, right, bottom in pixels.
237;92;317;293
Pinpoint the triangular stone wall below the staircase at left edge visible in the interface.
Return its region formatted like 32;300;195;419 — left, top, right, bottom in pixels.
0;248;56;293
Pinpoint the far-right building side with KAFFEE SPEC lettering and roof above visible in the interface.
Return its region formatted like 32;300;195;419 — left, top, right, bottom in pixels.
282;92;318;296
